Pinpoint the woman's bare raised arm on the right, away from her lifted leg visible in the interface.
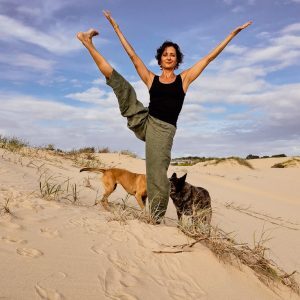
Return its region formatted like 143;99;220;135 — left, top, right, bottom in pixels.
181;21;252;92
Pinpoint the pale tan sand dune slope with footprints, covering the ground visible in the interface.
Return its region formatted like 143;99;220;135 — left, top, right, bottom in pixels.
0;150;300;300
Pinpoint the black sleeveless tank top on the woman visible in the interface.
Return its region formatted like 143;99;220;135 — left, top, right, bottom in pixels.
149;75;185;127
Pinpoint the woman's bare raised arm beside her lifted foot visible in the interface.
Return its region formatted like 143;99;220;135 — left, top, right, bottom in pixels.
103;11;154;89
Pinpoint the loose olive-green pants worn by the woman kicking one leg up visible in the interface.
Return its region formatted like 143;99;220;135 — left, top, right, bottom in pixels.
107;70;176;219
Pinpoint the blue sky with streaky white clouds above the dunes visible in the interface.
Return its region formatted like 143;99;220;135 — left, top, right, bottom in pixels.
0;0;300;157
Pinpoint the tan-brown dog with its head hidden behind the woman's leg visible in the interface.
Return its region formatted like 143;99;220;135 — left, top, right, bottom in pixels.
80;168;147;209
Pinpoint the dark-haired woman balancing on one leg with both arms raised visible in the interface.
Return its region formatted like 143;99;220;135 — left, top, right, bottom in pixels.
77;11;251;223
